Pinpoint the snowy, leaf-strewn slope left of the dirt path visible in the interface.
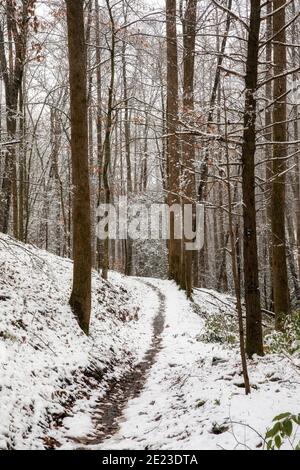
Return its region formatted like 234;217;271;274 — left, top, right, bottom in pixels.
0;235;158;449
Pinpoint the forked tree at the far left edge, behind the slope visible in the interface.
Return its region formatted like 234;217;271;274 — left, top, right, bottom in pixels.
0;0;37;238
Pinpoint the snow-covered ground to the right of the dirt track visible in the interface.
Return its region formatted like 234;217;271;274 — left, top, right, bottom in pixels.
96;280;300;450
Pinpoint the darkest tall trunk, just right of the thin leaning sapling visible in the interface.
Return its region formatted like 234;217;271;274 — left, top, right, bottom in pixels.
242;0;263;357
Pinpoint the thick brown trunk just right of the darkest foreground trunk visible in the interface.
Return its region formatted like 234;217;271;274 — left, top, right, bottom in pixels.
272;0;289;330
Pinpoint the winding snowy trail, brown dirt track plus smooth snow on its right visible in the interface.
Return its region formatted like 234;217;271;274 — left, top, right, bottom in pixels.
71;279;207;450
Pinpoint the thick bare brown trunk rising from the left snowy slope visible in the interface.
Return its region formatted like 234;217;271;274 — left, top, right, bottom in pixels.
66;0;92;334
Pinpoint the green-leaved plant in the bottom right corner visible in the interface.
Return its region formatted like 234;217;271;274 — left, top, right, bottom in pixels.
265;413;300;450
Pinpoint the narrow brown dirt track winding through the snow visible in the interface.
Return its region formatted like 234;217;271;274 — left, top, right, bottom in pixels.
75;281;166;449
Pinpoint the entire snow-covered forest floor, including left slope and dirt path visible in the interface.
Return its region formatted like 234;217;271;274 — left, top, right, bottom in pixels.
0;236;300;450
